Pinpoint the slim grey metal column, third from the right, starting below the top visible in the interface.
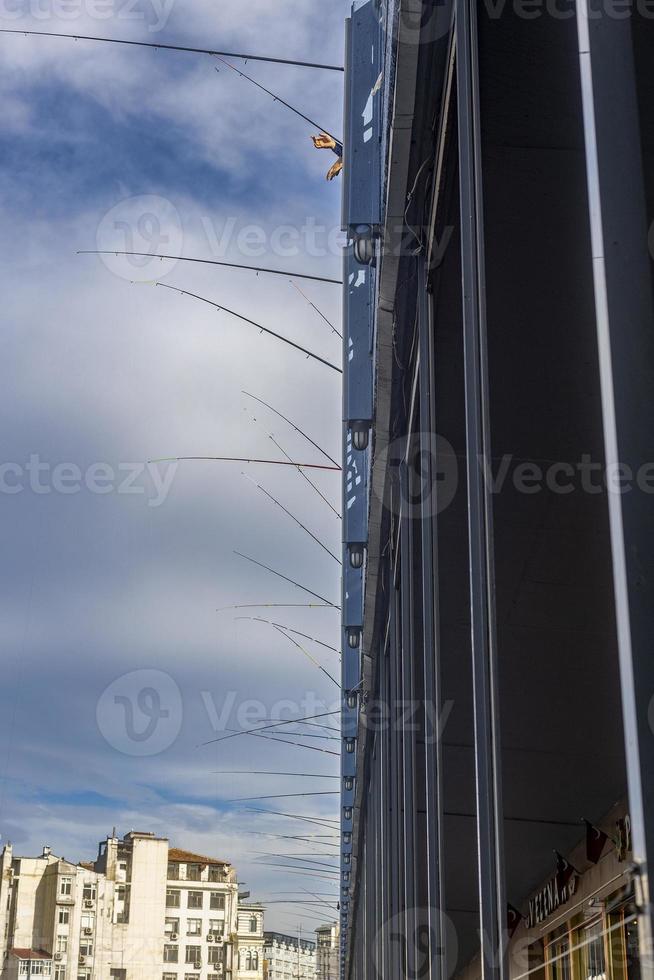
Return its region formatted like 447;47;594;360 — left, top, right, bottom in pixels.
418;256;446;980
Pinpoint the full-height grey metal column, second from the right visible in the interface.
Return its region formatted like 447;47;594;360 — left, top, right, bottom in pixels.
456;0;507;980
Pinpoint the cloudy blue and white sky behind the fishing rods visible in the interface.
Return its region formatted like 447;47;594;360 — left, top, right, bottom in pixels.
0;0;346;931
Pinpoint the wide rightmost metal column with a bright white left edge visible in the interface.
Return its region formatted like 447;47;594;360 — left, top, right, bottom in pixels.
577;0;654;968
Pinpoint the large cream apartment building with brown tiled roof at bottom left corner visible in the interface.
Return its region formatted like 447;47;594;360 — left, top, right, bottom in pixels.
0;831;263;980
